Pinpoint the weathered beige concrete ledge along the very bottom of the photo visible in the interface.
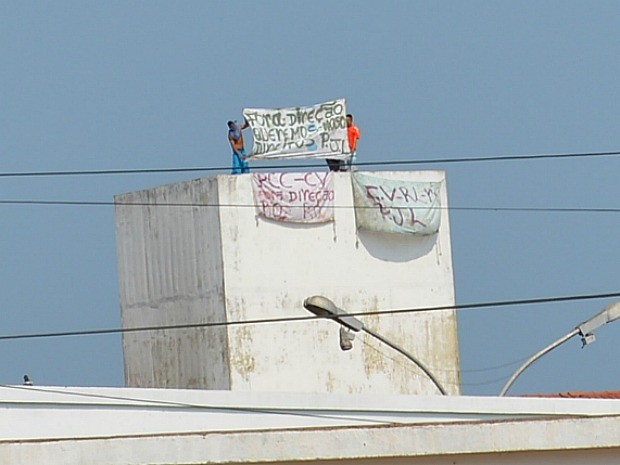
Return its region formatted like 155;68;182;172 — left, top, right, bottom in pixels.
0;415;620;465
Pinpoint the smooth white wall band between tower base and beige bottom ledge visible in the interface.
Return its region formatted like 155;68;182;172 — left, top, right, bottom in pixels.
6;386;620;438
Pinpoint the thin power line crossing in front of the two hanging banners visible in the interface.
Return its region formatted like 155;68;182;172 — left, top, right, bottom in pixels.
0;199;620;213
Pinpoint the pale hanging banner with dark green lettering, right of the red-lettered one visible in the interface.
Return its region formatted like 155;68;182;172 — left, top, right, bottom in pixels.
351;172;441;235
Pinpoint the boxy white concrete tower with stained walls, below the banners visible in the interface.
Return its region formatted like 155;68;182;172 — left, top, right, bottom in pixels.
117;171;460;394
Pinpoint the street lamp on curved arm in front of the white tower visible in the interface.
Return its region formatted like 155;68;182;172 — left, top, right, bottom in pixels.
304;295;447;396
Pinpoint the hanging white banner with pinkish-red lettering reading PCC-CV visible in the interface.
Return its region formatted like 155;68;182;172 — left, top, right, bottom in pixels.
252;172;334;223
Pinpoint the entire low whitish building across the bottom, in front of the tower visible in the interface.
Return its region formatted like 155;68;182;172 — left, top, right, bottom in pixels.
0;386;620;465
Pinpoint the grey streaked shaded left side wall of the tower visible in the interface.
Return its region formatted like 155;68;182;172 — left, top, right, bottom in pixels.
115;179;230;389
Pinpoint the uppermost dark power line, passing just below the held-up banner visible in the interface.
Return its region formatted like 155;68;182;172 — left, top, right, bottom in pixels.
0;152;620;178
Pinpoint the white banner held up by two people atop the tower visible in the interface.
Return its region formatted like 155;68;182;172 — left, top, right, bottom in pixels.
243;99;350;160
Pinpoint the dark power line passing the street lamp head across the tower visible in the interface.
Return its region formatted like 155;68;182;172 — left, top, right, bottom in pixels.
0;292;620;341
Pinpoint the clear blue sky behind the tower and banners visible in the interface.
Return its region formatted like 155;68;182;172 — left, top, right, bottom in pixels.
0;0;620;395
